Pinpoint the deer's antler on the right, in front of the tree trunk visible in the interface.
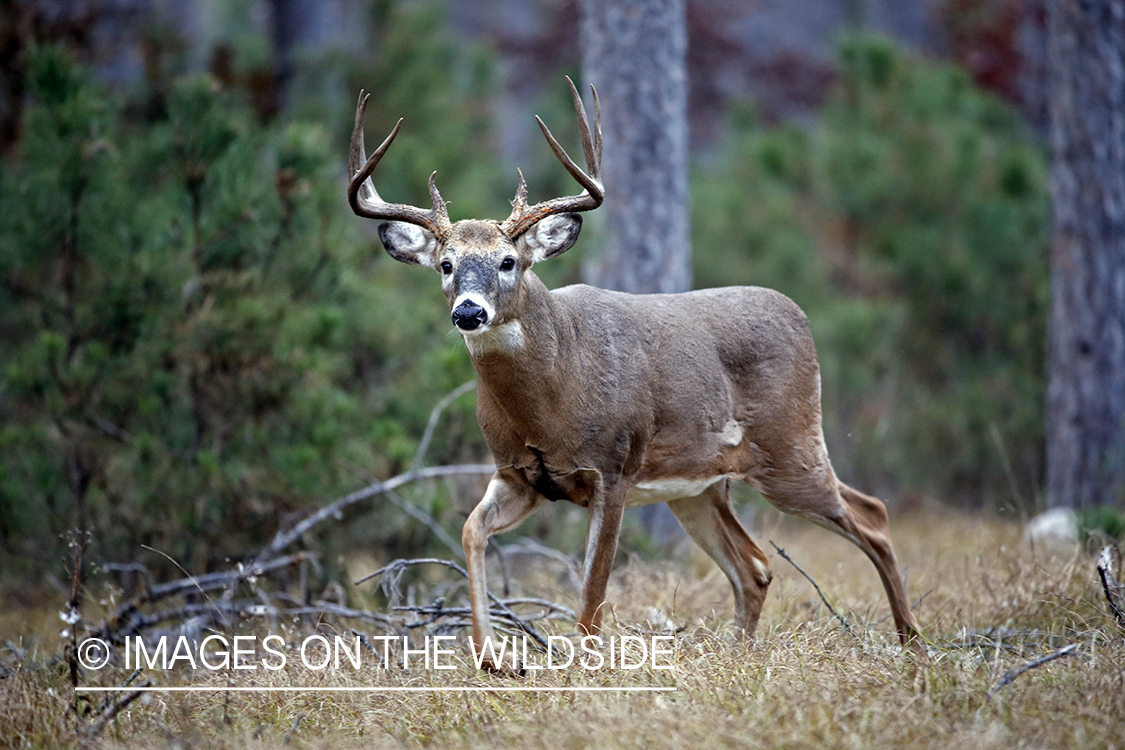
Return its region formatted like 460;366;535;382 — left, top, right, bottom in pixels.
501;76;605;237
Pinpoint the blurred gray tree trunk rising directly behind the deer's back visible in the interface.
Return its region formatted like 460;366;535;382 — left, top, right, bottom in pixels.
582;0;692;293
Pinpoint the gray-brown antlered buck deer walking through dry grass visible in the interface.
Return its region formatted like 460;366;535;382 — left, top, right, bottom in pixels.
348;78;926;668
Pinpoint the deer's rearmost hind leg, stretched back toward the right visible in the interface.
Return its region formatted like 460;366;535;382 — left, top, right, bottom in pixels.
748;452;925;654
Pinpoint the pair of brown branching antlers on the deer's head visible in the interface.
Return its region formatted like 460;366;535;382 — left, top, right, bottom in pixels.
348;76;605;241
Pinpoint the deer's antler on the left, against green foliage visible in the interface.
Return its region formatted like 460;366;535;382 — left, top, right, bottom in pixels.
348;91;450;240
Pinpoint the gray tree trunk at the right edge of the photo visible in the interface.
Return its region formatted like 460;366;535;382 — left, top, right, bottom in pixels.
1047;0;1125;507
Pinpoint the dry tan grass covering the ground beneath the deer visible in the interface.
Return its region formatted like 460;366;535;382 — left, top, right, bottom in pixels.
0;514;1125;750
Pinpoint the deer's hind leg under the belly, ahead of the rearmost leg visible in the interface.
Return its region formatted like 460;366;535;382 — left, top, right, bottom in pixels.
668;479;773;635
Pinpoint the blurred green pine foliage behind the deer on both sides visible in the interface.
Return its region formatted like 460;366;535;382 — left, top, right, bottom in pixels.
0;2;1047;571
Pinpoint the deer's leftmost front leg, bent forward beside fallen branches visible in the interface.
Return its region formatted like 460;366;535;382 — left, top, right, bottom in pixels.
461;471;543;665
